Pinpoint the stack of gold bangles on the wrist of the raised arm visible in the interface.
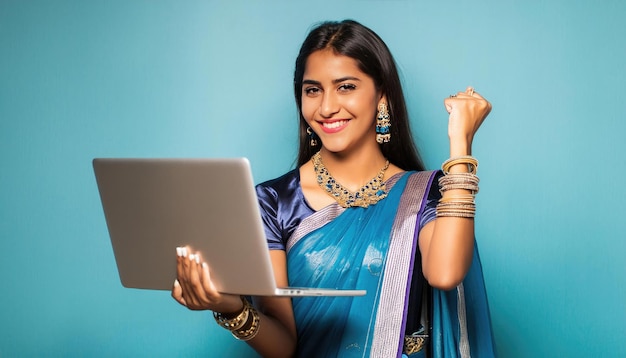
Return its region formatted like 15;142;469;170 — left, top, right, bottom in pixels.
437;156;479;218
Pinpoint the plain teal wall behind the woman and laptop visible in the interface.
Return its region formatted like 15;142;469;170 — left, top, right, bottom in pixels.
0;0;626;357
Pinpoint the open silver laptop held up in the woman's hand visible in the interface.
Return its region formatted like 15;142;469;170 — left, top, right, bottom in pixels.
93;158;366;296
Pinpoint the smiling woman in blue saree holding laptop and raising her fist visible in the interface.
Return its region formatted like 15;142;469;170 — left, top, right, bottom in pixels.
172;20;493;357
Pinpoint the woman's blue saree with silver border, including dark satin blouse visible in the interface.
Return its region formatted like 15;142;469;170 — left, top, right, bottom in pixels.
257;171;494;357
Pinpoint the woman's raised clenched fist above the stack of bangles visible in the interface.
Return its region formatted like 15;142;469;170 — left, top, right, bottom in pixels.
444;87;491;156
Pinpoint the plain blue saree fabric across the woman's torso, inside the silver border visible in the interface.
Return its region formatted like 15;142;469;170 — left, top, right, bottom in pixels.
287;175;408;357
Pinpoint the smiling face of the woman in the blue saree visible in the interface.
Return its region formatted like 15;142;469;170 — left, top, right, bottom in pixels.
301;50;385;153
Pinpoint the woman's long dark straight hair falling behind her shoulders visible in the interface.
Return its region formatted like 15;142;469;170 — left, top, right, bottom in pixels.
293;20;424;170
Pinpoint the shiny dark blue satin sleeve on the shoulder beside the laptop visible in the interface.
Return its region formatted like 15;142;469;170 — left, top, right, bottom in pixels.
256;169;314;250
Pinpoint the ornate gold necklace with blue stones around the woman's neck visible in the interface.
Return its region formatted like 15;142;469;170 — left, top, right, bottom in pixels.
312;152;389;208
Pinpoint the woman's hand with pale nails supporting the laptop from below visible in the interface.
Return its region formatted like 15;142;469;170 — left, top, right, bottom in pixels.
172;247;243;314
